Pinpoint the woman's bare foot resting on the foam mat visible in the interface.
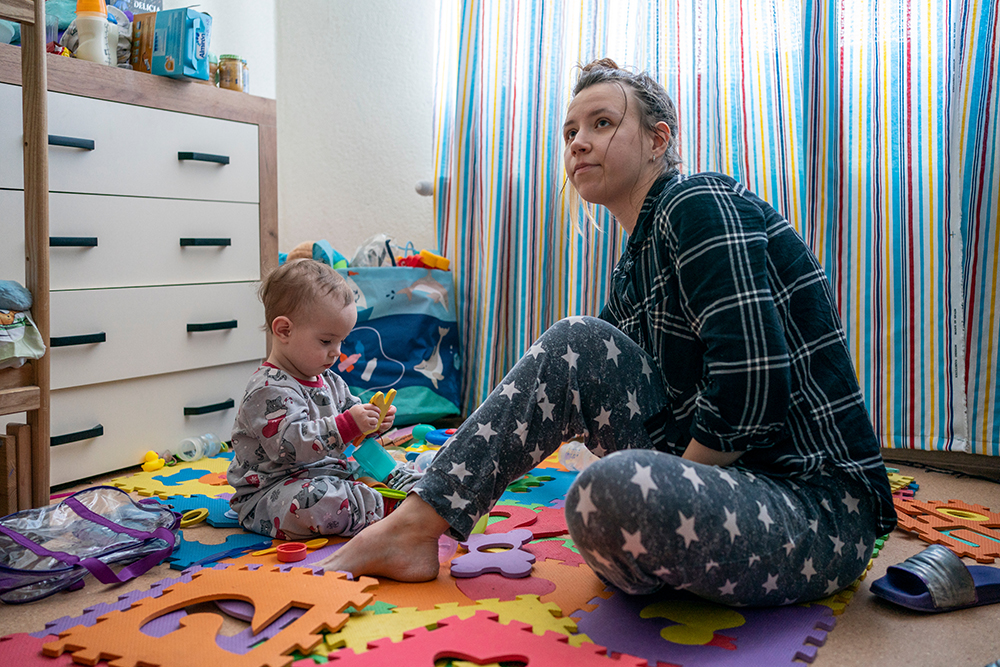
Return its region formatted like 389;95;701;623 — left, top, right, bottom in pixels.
312;493;448;582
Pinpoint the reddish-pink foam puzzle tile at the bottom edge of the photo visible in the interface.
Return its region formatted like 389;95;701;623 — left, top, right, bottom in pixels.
304;611;648;667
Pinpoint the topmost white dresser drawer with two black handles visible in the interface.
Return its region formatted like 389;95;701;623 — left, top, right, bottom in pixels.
0;86;260;202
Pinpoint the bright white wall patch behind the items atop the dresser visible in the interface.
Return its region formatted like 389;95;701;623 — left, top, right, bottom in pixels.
163;0;275;99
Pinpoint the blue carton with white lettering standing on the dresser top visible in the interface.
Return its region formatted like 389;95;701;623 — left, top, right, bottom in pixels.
152;7;212;81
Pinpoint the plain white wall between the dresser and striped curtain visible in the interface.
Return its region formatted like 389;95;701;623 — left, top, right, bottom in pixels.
278;0;438;259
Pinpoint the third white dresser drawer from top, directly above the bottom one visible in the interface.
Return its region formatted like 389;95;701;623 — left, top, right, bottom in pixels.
50;283;266;389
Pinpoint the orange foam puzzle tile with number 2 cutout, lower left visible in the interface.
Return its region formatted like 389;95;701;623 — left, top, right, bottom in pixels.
42;568;377;667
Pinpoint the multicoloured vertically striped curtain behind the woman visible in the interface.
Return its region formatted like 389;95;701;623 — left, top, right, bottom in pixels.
435;0;1000;455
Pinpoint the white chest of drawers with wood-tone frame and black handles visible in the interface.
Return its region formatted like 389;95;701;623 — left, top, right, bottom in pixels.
0;45;277;485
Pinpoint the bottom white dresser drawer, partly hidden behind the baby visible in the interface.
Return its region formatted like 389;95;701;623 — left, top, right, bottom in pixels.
50;360;260;484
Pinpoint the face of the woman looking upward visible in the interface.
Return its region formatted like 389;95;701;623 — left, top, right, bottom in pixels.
563;83;653;218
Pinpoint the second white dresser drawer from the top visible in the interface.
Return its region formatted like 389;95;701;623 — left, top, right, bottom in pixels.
0;190;260;290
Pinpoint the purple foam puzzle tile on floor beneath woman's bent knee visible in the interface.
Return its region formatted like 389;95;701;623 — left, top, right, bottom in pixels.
569;591;836;667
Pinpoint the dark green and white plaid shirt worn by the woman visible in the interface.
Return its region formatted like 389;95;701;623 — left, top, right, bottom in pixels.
601;173;896;534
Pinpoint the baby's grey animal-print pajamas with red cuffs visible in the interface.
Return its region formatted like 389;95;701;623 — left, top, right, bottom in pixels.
227;363;383;540
